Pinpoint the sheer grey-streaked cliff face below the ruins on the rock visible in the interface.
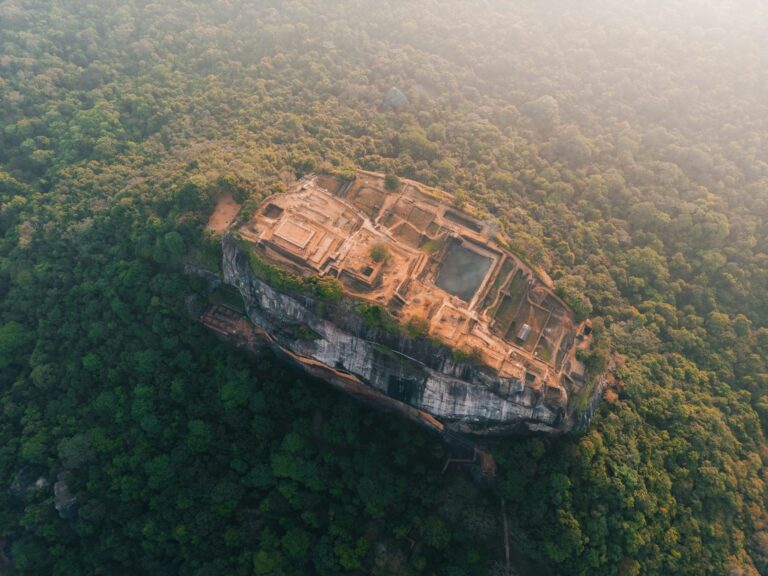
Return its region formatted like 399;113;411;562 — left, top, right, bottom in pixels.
222;235;574;434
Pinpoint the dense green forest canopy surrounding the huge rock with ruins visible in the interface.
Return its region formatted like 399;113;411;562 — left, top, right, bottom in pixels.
0;0;768;576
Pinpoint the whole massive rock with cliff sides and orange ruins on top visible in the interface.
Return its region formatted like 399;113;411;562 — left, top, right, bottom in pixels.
203;171;602;435
